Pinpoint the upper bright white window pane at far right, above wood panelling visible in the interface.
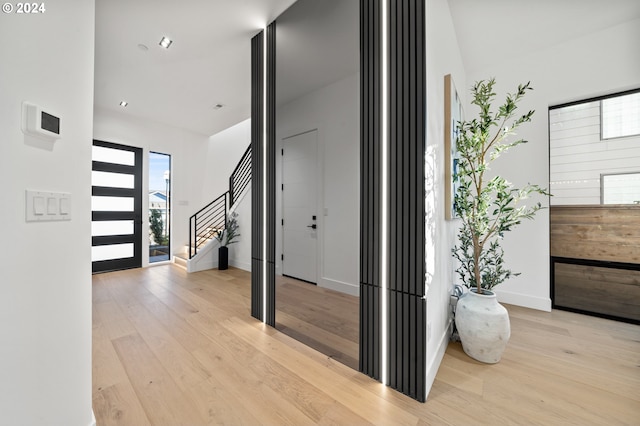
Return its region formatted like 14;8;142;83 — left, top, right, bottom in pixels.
602;93;640;139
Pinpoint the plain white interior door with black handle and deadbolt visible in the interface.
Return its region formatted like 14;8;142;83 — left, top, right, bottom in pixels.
282;130;318;284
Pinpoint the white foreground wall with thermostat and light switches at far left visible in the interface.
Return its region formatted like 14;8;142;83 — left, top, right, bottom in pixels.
0;0;95;426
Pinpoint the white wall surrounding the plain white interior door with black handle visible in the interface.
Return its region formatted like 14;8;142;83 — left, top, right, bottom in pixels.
276;73;360;295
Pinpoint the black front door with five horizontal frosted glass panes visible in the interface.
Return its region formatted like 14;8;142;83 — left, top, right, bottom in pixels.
91;140;142;273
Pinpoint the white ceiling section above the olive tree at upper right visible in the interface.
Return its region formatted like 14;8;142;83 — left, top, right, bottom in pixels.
448;0;640;72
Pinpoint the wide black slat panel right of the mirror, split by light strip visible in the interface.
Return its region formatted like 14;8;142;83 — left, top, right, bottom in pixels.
360;0;426;401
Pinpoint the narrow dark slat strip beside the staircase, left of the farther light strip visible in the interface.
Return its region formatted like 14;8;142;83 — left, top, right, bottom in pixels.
251;32;264;320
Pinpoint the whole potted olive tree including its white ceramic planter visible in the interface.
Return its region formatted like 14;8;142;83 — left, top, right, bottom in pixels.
453;79;549;363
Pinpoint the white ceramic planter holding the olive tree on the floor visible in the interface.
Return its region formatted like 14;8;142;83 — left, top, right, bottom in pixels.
456;290;511;364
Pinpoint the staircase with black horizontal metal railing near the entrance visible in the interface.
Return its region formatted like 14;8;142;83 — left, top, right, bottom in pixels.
174;145;251;272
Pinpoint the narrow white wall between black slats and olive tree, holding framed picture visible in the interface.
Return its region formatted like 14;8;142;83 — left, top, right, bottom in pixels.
425;0;466;398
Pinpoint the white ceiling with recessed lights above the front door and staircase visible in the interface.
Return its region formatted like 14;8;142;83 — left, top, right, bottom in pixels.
94;0;295;136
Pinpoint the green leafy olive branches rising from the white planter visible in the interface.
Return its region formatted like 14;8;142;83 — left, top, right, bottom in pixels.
453;78;549;293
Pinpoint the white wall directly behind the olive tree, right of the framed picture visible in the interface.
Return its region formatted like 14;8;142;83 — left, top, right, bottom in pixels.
465;17;640;310
